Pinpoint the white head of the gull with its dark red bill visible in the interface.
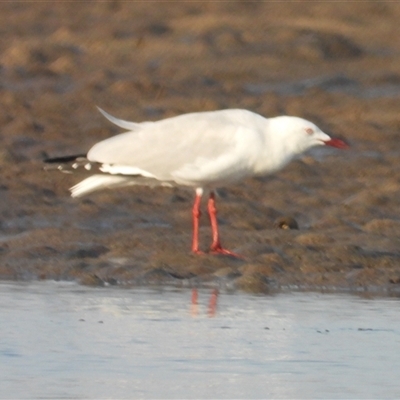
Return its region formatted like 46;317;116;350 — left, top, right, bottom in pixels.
272;116;349;154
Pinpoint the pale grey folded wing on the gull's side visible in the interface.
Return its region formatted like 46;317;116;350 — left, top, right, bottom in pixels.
88;110;261;185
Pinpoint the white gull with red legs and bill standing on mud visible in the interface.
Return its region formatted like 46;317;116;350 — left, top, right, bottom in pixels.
44;108;348;256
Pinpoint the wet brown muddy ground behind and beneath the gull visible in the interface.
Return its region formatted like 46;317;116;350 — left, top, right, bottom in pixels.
0;1;400;293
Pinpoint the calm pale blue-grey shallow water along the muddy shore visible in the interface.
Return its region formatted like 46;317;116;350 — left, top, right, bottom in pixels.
0;282;400;399
